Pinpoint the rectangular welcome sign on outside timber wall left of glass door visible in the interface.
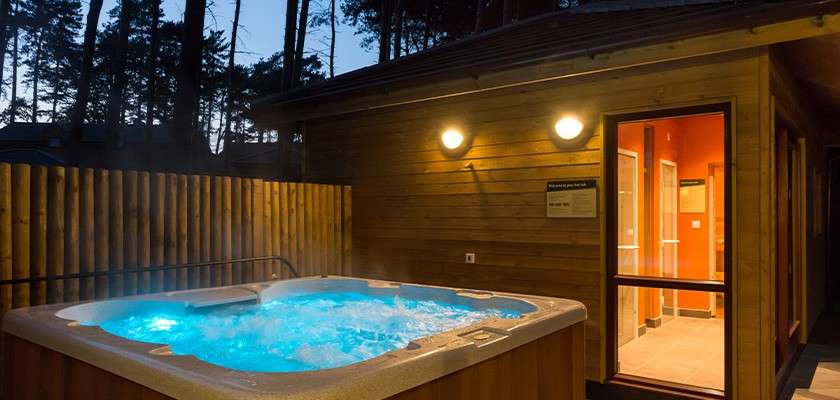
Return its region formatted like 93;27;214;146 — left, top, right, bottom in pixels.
545;179;598;218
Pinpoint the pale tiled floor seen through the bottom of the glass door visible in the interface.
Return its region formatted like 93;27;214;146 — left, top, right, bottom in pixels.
618;317;725;390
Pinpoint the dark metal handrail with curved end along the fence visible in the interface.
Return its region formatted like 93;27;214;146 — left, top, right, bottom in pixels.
0;256;300;286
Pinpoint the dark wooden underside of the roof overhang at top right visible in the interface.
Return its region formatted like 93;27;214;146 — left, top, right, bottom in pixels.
780;34;840;138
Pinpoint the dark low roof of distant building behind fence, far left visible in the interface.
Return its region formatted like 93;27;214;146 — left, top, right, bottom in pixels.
0;122;172;144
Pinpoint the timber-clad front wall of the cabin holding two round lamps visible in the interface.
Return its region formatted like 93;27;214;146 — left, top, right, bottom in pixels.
304;49;773;399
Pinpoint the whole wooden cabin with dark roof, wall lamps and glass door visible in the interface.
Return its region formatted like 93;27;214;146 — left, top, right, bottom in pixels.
251;0;840;400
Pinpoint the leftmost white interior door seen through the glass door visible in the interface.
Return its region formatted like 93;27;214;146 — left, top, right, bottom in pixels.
617;149;639;346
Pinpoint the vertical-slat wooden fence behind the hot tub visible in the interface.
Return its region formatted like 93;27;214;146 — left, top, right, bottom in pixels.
0;163;351;315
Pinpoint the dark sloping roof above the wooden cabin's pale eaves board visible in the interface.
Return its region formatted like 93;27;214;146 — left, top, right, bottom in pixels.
260;0;840;108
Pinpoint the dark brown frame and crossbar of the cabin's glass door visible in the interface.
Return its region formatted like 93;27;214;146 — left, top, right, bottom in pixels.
603;101;734;398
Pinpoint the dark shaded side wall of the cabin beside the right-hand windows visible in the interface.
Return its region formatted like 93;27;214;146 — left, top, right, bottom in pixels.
770;48;828;342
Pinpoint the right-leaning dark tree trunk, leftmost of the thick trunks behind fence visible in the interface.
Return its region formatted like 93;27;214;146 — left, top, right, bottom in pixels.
69;0;102;165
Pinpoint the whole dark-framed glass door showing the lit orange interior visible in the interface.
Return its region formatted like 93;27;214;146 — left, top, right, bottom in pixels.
606;106;728;393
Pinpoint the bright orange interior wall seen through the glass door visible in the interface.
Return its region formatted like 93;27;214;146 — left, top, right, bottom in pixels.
618;115;724;325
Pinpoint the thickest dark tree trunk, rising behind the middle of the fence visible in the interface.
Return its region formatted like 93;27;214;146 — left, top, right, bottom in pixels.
172;0;207;169
